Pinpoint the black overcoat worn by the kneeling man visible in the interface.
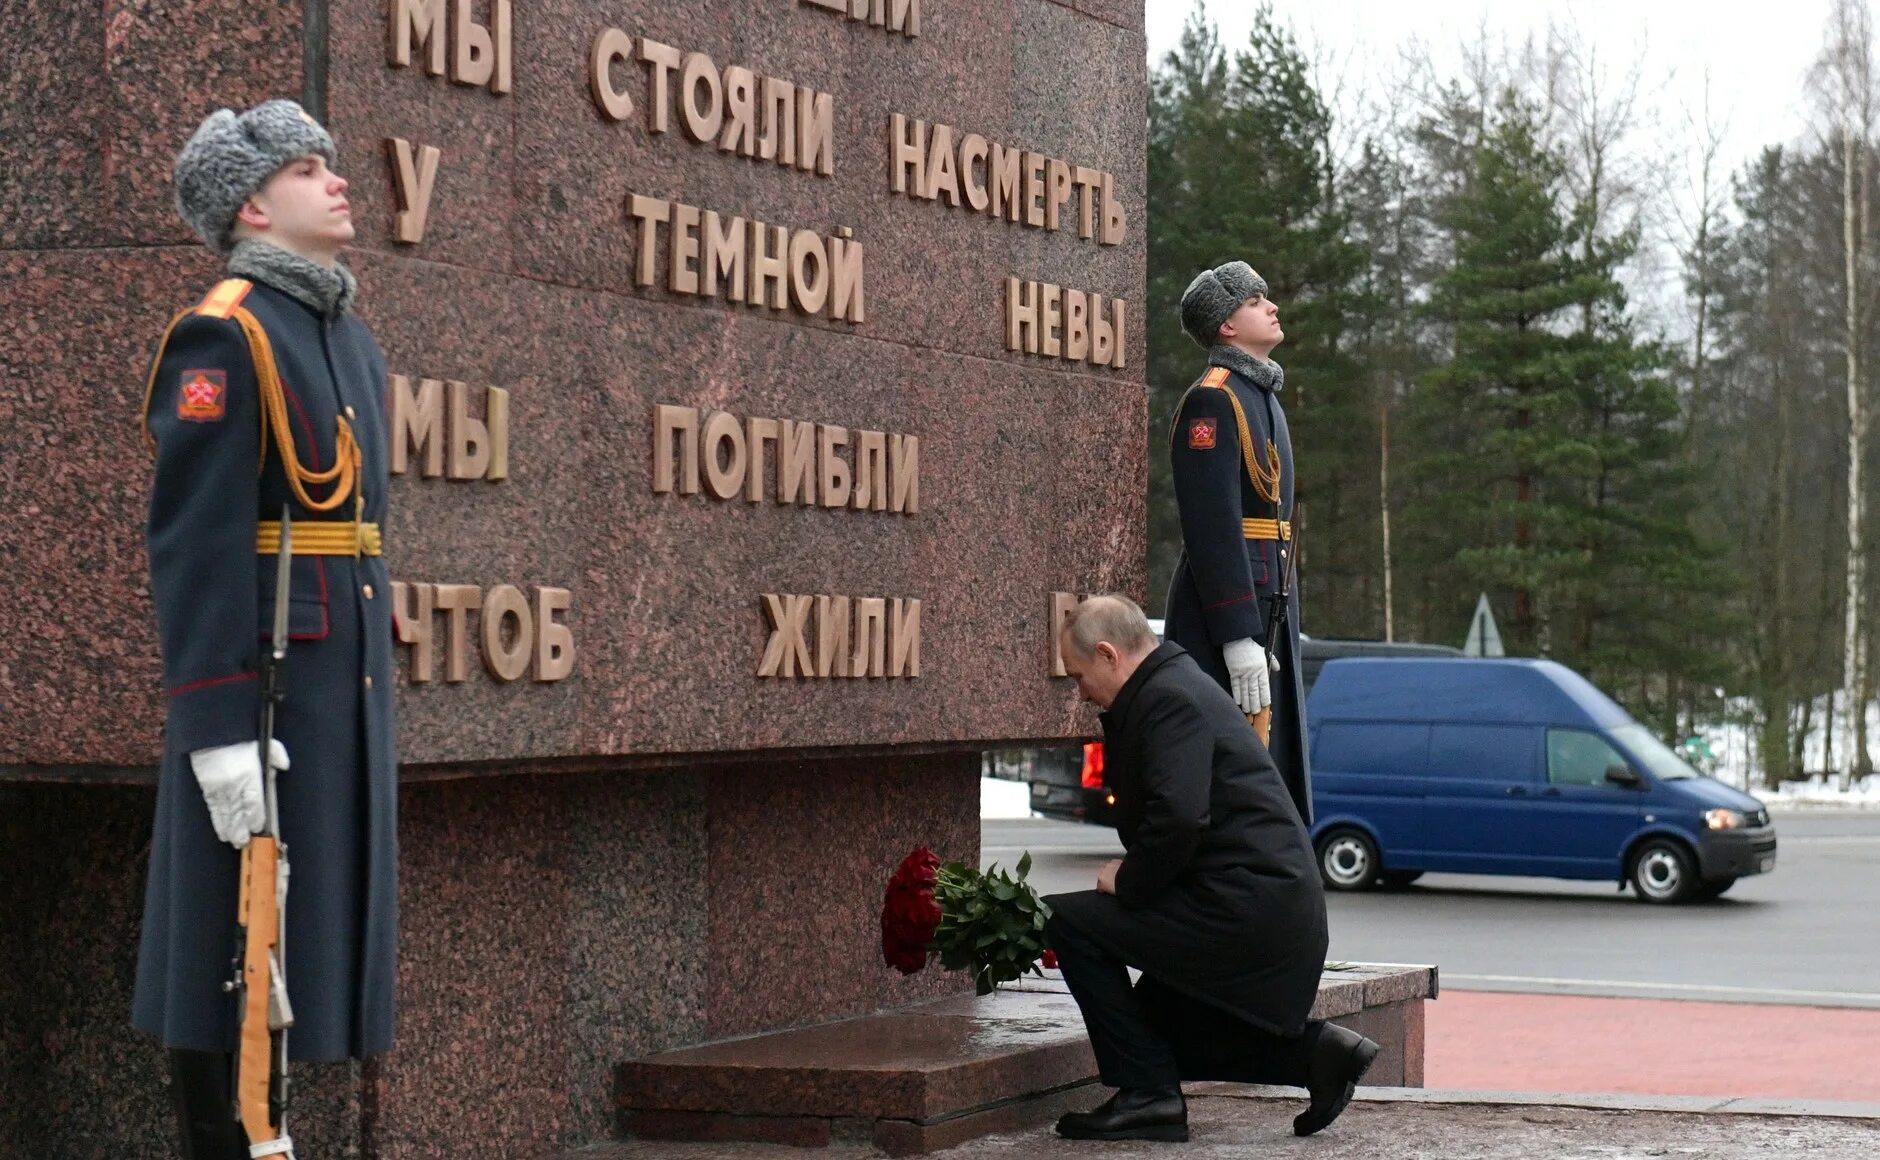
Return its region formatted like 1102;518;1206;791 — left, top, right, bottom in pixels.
1049;643;1327;1034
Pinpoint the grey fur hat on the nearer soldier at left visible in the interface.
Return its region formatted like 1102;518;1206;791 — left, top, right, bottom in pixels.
175;100;338;258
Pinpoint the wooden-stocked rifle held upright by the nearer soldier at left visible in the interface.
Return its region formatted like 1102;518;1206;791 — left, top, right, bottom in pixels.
224;508;293;1160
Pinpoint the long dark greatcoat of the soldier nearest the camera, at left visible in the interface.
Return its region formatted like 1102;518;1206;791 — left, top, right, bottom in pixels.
133;270;399;1060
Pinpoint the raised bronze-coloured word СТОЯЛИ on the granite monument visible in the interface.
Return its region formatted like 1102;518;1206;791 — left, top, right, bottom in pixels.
588;28;835;177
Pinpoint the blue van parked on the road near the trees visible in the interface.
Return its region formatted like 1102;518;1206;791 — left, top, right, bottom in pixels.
1307;658;1775;902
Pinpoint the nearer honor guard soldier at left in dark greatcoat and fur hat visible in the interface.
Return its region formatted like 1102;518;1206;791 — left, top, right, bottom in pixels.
133;100;399;1160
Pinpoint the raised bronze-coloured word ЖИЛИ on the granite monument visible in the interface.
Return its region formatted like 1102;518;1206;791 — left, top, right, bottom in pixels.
758;592;921;677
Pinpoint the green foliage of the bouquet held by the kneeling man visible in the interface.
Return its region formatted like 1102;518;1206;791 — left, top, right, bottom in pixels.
932;854;1051;995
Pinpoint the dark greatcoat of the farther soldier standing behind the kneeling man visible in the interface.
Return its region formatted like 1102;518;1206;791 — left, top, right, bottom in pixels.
1164;350;1312;823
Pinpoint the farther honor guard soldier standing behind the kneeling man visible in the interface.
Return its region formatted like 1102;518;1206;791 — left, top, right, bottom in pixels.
1166;261;1312;825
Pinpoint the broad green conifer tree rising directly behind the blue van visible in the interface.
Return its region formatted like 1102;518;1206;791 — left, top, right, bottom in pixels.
1416;92;1716;713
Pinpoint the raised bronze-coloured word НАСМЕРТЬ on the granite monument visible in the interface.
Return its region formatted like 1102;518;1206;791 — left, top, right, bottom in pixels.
887;113;1124;246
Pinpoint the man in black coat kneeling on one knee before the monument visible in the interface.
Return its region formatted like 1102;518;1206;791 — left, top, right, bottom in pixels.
1045;596;1378;1141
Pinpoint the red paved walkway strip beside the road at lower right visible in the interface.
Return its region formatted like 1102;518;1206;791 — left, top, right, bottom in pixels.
1423;991;1880;1102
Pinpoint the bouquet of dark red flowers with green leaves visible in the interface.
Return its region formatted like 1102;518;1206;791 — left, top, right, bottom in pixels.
882;846;1057;995
